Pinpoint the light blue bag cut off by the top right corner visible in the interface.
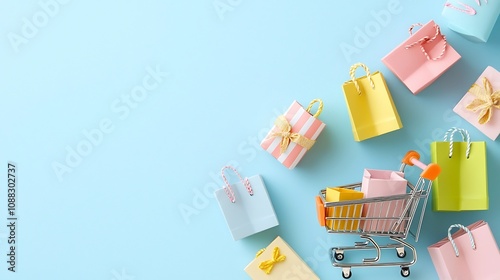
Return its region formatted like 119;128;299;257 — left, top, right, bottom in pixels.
442;0;500;43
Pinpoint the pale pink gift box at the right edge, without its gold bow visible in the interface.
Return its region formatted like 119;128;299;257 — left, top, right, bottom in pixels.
453;66;500;141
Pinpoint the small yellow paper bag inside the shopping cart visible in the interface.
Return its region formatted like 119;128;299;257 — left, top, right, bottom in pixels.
325;188;363;231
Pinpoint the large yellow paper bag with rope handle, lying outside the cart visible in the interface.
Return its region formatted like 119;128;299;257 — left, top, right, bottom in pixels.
342;63;403;141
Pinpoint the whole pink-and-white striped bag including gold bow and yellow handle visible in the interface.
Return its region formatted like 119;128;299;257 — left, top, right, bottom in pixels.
260;99;325;169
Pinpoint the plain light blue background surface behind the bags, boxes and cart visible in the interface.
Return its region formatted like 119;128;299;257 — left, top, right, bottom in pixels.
0;0;500;280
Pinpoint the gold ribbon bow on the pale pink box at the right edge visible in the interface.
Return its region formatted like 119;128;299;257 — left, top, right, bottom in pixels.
465;77;500;124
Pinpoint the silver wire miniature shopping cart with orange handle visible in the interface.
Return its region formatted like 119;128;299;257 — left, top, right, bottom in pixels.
316;151;441;279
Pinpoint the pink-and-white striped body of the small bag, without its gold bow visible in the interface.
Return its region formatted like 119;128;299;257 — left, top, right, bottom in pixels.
260;100;325;169
